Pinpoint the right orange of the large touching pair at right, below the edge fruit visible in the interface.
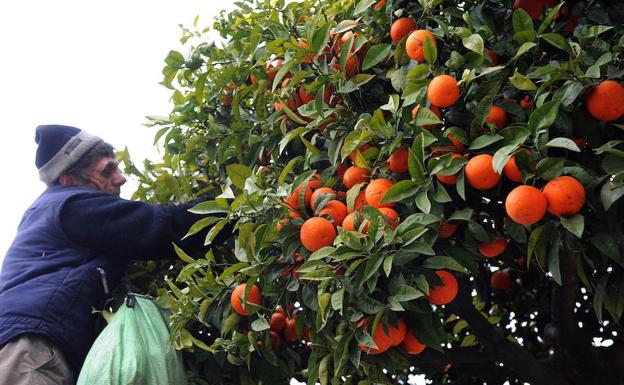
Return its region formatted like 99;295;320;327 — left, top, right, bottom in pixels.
543;176;585;216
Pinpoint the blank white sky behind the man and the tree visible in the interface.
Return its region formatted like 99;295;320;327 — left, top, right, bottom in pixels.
0;0;233;261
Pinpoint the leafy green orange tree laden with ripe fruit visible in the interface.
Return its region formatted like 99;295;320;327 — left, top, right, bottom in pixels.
118;0;624;384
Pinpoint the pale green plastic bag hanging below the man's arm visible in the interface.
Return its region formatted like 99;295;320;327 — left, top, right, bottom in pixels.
77;295;187;385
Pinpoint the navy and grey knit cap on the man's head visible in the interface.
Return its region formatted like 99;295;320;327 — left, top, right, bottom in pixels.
35;124;102;186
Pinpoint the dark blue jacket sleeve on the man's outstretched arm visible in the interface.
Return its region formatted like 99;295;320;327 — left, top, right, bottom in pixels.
61;193;232;259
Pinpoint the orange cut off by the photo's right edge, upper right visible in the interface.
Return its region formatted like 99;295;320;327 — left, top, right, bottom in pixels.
585;80;624;122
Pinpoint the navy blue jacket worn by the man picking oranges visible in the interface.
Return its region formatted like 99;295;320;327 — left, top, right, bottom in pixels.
0;186;219;374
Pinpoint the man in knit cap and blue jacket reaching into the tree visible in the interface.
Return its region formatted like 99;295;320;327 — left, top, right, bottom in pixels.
0;125;230;385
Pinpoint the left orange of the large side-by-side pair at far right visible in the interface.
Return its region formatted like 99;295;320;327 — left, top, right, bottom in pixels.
505;185;547;225
